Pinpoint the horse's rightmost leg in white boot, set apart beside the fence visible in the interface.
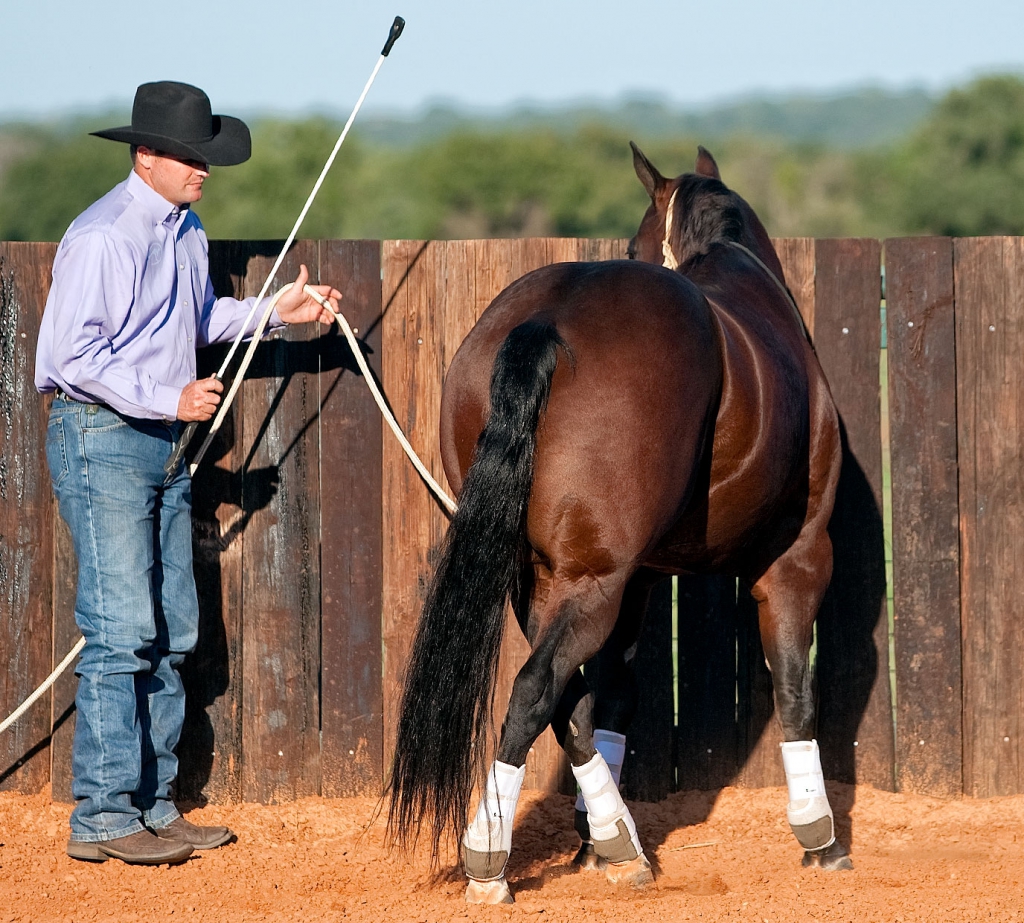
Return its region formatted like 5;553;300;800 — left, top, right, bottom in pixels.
753;530;853;870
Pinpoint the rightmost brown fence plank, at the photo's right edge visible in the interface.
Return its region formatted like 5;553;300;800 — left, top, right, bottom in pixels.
953;238;1024;798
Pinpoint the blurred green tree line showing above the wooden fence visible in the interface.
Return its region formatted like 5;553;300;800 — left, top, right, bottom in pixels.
0;75;1024;241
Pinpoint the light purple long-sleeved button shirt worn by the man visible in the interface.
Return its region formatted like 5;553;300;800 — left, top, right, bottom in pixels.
36;171;282;421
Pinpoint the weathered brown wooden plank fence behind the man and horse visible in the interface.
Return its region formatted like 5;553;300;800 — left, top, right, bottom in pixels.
0;238;1024;802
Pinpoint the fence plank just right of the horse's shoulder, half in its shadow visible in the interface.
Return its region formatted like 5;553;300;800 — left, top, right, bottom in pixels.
812;234;894;791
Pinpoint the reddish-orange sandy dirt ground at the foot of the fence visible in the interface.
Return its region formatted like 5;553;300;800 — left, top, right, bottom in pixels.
0;785;1024;923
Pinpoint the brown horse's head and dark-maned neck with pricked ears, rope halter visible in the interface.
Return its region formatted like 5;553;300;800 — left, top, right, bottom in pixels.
628;141;782;279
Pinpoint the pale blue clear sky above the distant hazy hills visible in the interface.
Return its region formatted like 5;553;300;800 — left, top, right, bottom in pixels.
0;0;1024;118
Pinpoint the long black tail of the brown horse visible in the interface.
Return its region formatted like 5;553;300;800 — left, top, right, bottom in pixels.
388;321;572;859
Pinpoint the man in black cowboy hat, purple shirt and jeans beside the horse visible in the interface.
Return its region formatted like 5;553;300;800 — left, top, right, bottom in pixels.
36;81;341;865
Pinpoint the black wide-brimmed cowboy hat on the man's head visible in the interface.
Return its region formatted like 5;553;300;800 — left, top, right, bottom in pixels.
90;80;252;167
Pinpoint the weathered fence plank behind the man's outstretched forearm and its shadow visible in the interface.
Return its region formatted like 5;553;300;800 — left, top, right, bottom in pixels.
242;241;321;802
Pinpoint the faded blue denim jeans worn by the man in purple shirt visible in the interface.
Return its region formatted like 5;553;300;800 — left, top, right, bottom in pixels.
46;396;199;842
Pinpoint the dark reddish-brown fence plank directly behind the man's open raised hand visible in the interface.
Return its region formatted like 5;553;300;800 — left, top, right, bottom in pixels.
318;241;392;797
